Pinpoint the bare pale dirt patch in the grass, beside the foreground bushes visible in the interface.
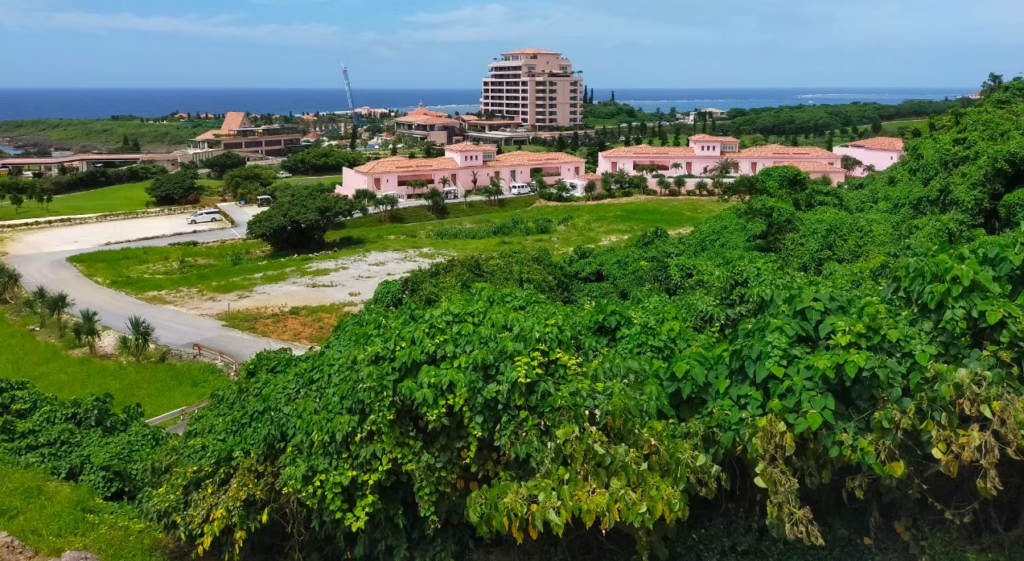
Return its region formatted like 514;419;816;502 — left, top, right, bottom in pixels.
155;252;437;316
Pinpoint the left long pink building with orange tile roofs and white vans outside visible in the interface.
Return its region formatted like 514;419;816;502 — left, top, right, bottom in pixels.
335;142;586;199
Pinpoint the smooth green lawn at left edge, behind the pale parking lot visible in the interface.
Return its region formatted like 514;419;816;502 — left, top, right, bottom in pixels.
0;181;150;221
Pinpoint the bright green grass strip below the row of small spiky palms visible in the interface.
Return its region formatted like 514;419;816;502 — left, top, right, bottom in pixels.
0;306;227;417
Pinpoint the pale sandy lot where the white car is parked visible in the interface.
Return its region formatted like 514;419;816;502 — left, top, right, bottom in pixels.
0;214;227;255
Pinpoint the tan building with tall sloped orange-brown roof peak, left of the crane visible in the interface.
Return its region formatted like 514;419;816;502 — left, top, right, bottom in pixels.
191;112;302;156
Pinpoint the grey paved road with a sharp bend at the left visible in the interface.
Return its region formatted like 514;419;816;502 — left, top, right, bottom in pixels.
5;205;305;362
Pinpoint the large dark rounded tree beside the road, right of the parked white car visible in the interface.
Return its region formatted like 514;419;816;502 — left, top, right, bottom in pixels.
248;183;358;251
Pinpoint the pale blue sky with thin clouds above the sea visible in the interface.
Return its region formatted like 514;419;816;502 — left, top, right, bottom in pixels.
0;0;1024;89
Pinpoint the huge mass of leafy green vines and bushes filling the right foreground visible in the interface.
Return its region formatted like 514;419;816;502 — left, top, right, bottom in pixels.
140;83;1024;559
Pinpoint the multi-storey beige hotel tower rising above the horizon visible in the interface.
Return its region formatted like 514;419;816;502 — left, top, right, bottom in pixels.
480;48;583;129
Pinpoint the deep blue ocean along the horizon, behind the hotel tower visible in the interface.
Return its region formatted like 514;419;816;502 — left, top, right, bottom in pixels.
0;87;977;121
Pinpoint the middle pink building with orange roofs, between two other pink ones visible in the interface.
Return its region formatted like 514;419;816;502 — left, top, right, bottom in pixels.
597;134;846;183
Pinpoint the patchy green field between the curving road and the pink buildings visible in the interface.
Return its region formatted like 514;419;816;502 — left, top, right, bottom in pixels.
71;198;725;303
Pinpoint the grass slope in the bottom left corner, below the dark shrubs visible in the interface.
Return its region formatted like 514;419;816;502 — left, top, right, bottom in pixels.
0;459;169;561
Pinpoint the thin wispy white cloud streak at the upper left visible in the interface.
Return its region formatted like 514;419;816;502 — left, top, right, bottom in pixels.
0;5;342;46
